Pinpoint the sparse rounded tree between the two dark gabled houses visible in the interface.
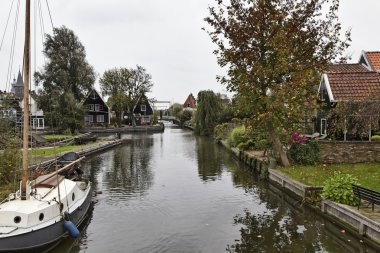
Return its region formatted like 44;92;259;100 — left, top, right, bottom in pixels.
99;66;153;127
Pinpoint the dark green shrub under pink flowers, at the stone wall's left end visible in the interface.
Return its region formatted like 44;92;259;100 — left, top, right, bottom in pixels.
289;141;321;165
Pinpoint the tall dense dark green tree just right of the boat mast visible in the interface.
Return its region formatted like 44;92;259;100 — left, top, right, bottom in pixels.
34;26;96;131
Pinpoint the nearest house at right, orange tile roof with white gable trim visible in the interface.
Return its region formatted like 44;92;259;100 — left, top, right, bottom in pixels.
316;51;380;137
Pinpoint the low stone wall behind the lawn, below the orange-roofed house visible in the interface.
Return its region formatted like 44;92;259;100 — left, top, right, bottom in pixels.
319;141;380;163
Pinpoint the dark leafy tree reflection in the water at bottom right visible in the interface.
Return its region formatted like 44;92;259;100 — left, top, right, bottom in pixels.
226;182;376;253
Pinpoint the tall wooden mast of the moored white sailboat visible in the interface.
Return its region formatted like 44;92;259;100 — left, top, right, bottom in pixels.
21;0;30;200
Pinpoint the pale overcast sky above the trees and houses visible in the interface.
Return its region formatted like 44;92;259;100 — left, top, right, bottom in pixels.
0;0;380;103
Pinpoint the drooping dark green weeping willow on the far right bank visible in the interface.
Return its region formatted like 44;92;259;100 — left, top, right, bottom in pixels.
195;90;221;136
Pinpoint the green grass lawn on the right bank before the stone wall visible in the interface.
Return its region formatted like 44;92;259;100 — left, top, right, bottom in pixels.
277;163;380;192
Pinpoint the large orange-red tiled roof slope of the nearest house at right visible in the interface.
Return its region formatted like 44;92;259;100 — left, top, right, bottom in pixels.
327;70;380;101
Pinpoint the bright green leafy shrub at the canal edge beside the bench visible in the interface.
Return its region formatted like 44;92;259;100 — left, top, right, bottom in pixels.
322;172;359;206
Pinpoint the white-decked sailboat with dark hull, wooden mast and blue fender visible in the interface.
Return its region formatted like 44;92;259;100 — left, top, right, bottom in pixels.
0;0;92;252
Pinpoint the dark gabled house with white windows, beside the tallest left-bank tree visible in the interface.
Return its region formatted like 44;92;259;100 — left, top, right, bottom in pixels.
83;89;111;126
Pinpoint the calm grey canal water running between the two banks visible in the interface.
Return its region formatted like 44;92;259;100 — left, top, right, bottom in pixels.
52;126;376;253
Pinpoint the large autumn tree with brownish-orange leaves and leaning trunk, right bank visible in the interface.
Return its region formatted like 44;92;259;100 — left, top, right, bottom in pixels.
205;0;350;166
